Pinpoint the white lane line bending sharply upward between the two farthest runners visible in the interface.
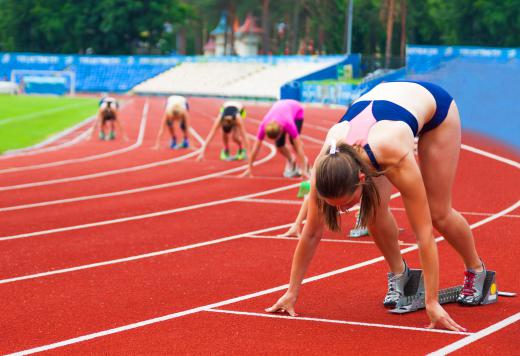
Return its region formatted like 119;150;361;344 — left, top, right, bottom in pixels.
0;99;149;175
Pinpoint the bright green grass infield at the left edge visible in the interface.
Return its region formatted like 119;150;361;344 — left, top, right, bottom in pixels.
0;95;98;153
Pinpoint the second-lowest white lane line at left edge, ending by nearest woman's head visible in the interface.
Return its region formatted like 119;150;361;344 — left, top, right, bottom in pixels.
0;183;300;241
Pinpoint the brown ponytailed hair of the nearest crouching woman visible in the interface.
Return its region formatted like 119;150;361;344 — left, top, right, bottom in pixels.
316;142;384;231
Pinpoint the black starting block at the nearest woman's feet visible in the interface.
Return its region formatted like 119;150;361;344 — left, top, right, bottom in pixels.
390;269;516;314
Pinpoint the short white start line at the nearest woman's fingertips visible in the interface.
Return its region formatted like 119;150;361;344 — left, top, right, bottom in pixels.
204;309;472;335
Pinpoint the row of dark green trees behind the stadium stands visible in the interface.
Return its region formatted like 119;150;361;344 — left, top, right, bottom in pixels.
0;0;520;58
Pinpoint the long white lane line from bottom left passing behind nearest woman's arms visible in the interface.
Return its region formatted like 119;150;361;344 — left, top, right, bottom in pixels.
7;202;520;355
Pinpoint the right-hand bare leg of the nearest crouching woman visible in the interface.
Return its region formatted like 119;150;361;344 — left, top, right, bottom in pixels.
418;101;482;271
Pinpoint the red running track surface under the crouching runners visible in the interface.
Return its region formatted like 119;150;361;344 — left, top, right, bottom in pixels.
0;98;520;354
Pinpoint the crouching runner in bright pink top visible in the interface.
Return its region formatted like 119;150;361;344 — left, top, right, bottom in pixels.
242;99;308;177
